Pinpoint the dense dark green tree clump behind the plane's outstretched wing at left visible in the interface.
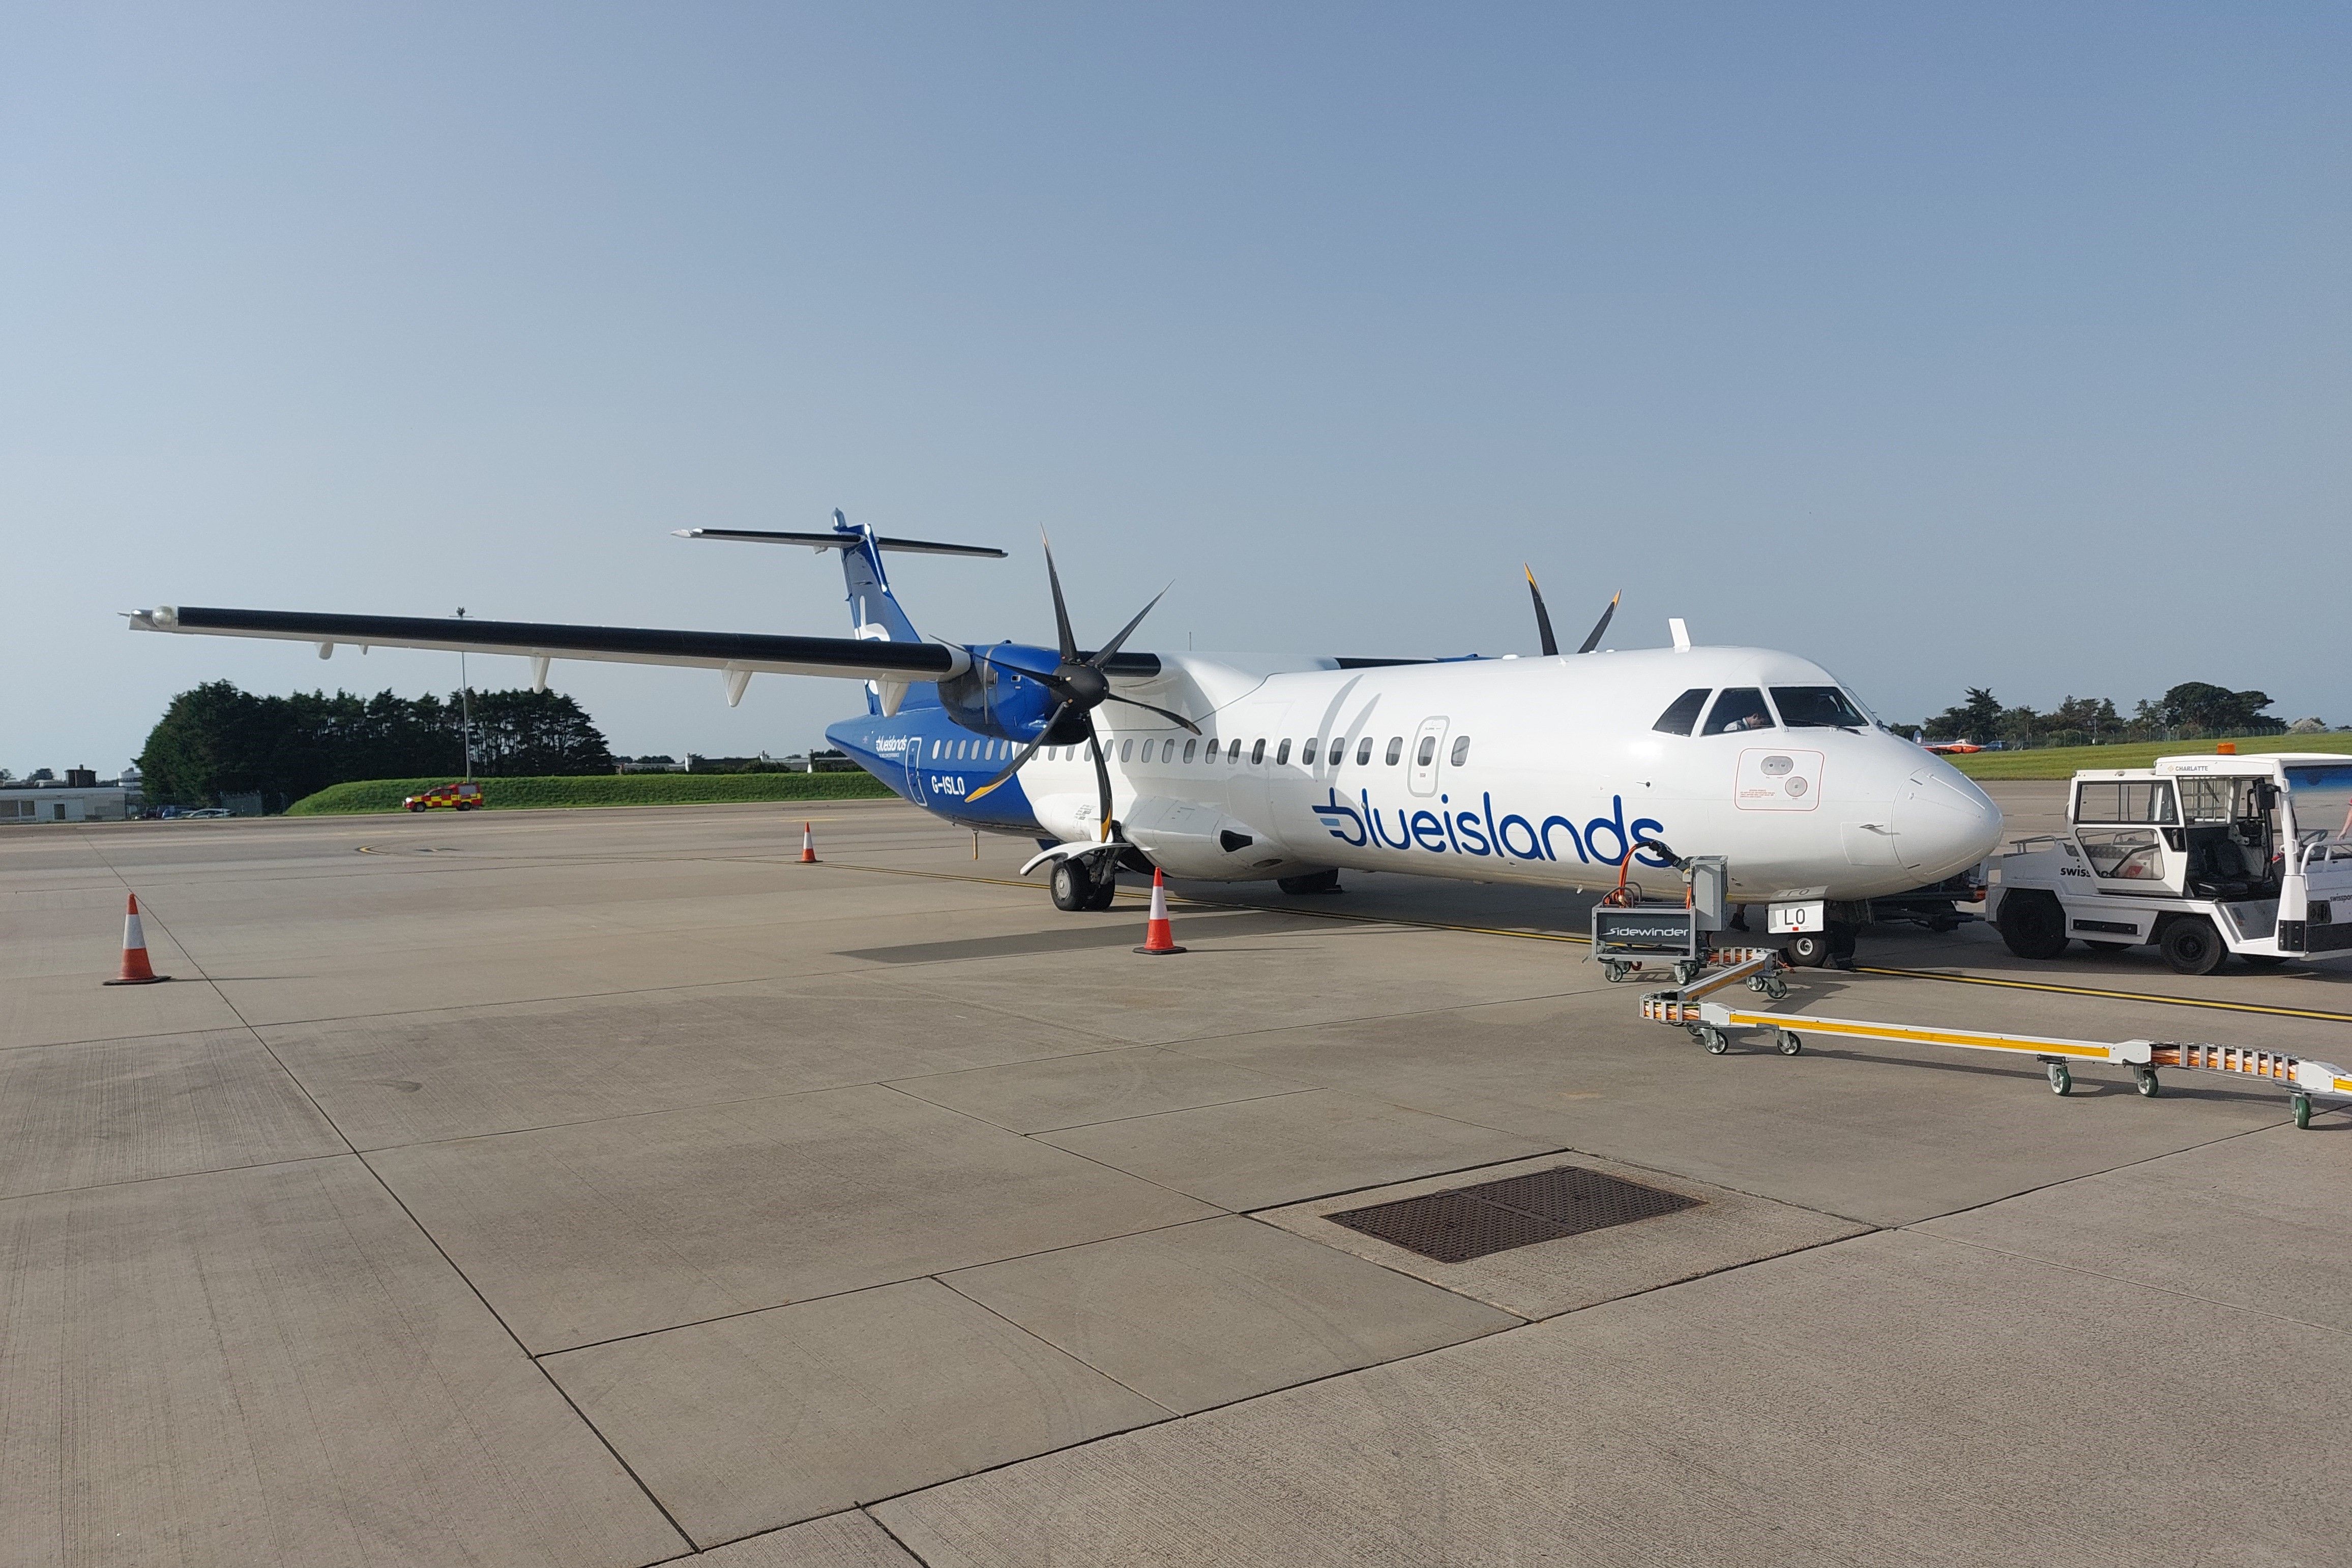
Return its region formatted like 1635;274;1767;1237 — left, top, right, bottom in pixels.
139;682;611;809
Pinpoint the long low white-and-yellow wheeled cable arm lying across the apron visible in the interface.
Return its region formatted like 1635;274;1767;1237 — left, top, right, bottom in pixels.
1642;992;2352;1126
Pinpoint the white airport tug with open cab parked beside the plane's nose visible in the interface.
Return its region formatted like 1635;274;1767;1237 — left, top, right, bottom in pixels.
1985;752;2352;975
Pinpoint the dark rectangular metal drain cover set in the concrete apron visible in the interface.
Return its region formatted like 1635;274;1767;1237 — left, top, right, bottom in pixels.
1327;1166;1698;1262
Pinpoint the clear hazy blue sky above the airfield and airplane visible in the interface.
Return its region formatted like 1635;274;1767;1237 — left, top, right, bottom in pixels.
0;3;2352;774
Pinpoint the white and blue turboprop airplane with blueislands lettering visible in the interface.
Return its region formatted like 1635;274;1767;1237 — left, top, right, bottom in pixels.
132;513;2002;959
